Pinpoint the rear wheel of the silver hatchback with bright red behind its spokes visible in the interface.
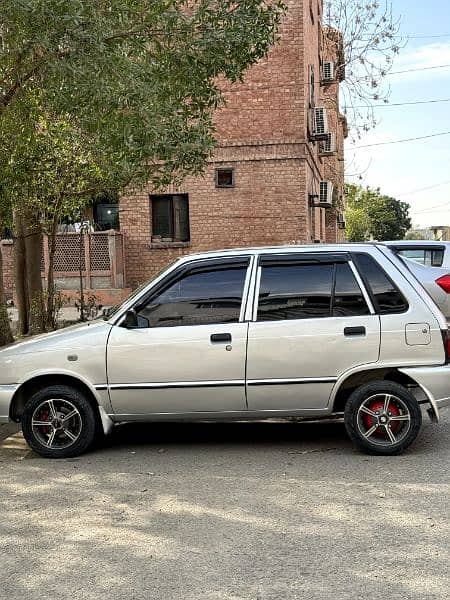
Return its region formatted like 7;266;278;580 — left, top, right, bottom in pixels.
344;381;422;456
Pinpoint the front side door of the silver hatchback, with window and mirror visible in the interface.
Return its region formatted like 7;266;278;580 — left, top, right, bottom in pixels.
107;256;251;418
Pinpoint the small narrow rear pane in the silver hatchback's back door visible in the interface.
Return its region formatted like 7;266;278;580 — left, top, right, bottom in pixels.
333;263;370;317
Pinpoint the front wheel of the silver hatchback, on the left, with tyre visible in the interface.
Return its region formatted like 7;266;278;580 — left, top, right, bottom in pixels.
22;385;97;458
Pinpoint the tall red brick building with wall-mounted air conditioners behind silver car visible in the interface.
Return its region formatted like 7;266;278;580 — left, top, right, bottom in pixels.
3;0;346;302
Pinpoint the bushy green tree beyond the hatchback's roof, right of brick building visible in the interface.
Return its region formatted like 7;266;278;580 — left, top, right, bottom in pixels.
345;184;411;242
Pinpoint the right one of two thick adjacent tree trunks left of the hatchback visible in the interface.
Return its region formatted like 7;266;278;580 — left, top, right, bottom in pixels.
24;213;46;335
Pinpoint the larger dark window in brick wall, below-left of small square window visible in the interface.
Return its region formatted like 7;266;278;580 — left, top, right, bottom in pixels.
150;194;190;242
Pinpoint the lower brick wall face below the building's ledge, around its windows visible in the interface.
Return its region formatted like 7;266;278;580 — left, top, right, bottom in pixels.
121;153;309;287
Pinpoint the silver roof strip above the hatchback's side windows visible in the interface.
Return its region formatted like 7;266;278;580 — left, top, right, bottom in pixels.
176;242;378;262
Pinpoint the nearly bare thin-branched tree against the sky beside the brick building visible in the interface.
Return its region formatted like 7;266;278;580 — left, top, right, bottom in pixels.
324;0;403;136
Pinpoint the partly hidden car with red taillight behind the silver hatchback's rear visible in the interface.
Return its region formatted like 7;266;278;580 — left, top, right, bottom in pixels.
384;240;450;322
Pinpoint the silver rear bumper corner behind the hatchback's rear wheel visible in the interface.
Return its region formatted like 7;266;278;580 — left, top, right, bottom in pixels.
399;365;450;421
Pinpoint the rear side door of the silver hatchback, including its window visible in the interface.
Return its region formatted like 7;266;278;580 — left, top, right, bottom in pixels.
247;252;380;410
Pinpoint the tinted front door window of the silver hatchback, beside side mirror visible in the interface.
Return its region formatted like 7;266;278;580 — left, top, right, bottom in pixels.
138;264;247;327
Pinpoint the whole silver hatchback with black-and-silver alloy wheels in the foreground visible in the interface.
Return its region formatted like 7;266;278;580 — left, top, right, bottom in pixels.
0;244;450;458
